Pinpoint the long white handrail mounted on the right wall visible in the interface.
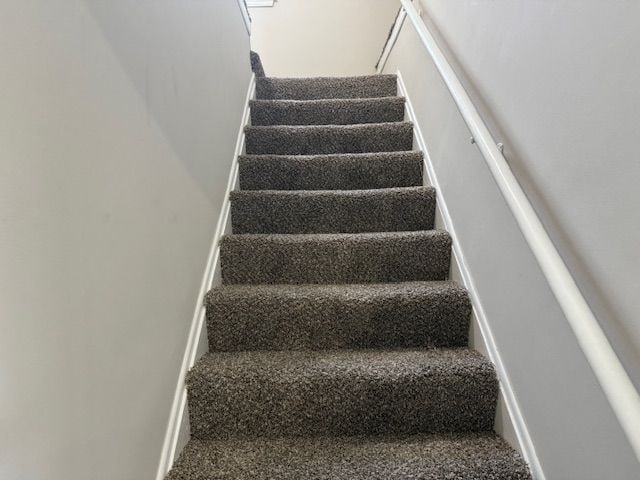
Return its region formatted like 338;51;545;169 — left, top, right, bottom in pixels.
400;0;640;461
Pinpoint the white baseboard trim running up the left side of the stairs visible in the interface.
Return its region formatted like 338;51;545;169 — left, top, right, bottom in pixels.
156;75;255;480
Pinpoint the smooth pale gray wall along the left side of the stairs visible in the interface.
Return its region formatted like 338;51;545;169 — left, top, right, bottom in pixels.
0;0;250;480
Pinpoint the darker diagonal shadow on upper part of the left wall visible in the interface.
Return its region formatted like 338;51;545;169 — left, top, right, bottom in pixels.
83;0;250;204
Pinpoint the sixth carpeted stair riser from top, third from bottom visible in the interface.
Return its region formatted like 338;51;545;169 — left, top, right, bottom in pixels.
221;232;451;284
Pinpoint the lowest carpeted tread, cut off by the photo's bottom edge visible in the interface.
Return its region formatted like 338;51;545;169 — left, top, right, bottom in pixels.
167;433;531;480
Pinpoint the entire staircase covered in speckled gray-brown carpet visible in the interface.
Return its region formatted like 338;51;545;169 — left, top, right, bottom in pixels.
167;75;531;480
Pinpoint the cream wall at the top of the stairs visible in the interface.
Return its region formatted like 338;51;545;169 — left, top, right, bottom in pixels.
250;0;400;77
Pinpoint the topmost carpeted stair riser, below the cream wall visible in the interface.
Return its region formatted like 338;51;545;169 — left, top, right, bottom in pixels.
256;75;398;100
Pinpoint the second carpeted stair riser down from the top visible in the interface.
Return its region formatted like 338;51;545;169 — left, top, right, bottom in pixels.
251;98;404;126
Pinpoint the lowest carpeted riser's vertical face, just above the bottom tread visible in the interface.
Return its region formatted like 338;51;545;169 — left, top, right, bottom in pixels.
189;364;497;439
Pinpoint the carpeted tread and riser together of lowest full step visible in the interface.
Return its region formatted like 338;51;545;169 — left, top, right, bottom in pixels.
187;348;498;439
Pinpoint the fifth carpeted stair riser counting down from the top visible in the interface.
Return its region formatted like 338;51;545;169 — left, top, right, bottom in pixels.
231;187;436;233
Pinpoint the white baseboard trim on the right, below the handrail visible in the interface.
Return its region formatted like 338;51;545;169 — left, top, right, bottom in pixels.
397;71;545;480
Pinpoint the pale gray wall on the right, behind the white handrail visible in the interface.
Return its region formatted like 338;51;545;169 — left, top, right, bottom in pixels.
385;0;640;480
